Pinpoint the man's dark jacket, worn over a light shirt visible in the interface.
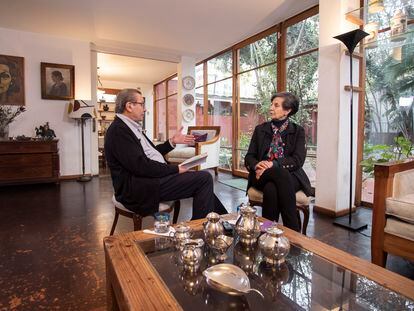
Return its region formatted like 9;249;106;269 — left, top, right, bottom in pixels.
105;118;178;216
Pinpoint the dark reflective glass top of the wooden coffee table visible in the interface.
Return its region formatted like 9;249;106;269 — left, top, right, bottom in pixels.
136;233;414;310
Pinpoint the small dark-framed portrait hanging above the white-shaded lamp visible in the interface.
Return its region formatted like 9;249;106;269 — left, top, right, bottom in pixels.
40;63;75;100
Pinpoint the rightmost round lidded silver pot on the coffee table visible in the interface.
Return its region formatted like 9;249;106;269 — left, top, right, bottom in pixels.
259;226;290;265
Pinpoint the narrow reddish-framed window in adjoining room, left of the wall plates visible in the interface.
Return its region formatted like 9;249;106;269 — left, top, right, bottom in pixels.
154;75;178;141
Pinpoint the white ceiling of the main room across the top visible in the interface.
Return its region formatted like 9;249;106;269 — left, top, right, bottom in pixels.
0;0;318;62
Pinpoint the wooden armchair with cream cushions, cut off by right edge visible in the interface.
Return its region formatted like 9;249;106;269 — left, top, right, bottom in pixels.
371;160;414;267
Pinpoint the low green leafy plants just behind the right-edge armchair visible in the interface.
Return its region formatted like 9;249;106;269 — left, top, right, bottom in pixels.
360;136;414;177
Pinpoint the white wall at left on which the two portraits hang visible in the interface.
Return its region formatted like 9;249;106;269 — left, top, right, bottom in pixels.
0;28;91;175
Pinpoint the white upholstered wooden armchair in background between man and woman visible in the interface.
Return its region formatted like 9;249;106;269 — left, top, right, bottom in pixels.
167;126;220;175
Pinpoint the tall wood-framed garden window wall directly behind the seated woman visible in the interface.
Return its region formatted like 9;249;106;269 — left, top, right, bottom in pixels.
155;7;319;178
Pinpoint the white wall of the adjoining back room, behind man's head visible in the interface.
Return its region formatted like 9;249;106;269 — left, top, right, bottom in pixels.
101;79;154;139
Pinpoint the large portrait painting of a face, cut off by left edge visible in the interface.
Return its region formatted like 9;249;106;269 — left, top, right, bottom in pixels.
0;55;25;106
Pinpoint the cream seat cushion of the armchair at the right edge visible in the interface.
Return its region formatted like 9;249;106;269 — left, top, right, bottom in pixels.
385;193;414;224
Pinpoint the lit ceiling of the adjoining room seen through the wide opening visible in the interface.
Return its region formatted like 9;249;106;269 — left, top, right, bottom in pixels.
98;53;177;86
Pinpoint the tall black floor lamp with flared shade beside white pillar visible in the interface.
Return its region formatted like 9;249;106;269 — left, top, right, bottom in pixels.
334;29;368;231
